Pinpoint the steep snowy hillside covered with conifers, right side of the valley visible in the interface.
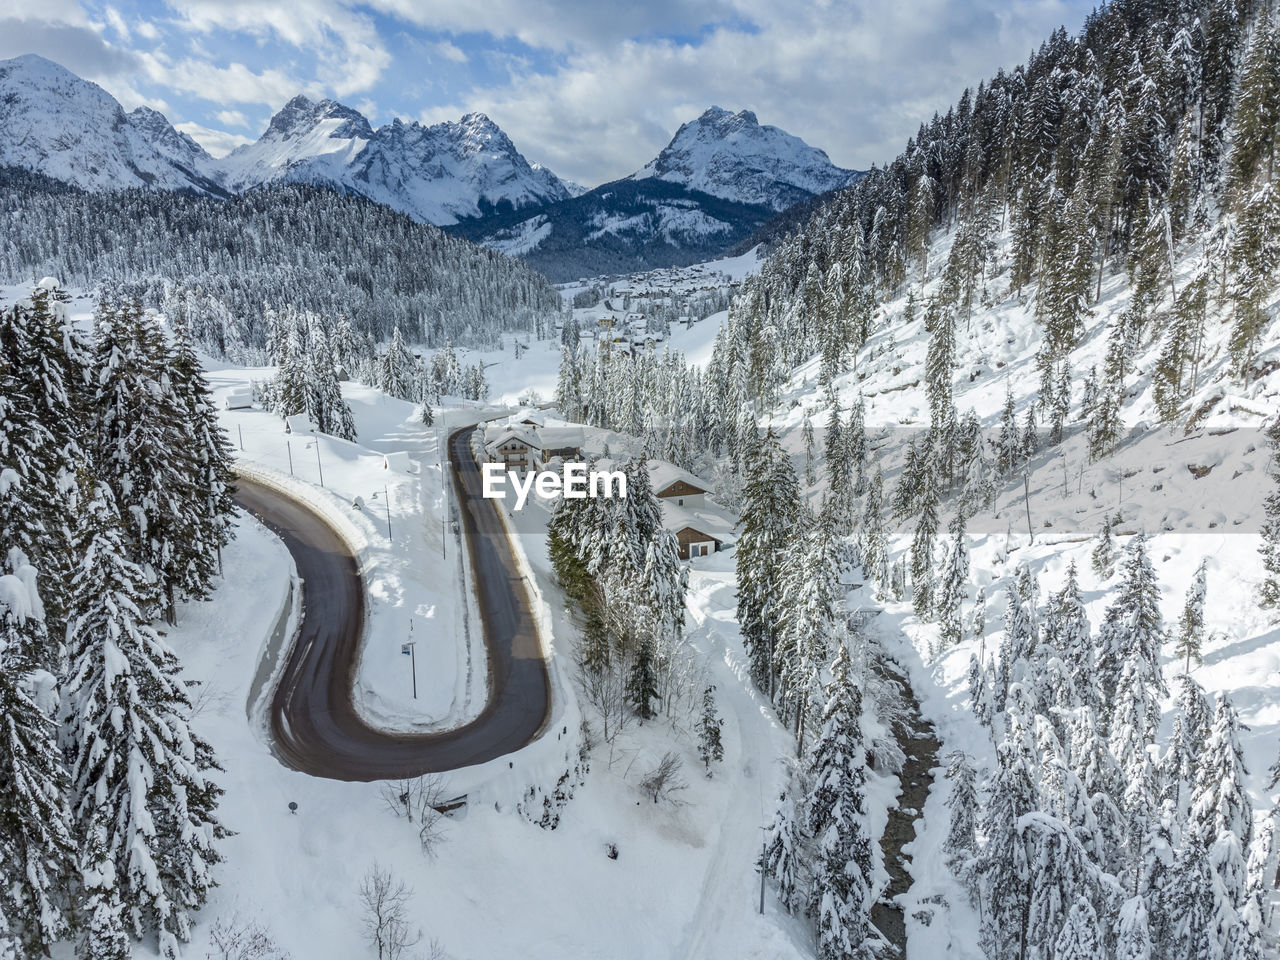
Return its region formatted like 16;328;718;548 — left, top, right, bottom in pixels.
558;1;1280;960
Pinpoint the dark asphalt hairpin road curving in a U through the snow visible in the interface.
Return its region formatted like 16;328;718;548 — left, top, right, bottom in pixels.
236;428;550;781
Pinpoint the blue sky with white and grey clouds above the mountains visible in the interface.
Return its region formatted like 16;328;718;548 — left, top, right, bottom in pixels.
0;0;1093;186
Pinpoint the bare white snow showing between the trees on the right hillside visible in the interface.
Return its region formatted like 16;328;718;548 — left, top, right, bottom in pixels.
747;216;1280;960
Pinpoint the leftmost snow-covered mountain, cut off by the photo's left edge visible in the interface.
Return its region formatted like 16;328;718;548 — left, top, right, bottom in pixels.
0;54;224;195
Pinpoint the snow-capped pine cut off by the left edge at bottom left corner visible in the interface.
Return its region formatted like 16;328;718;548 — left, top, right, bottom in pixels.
0;555;74;957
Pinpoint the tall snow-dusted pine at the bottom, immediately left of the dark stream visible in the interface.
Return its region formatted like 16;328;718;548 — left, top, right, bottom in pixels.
805;644;876;960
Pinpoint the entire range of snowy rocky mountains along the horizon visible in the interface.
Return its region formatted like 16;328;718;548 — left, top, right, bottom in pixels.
0;55;860;280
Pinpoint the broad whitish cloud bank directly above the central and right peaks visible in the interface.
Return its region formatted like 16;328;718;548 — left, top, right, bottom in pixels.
426;0;1075;183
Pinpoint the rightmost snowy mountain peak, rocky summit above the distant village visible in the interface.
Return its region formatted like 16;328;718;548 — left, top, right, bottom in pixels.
635;106;858;210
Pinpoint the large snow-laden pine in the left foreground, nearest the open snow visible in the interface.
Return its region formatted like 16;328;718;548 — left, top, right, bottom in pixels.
64;485;227;960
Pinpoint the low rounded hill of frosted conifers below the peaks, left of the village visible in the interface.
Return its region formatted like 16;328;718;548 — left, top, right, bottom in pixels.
0;169;559;364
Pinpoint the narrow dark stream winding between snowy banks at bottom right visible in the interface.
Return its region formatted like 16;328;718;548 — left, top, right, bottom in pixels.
872;666;941;956
